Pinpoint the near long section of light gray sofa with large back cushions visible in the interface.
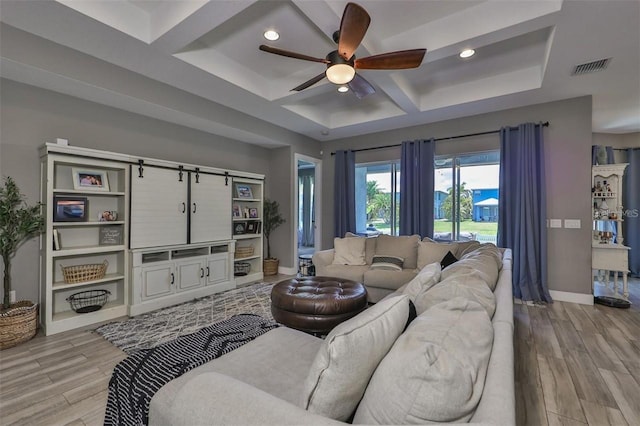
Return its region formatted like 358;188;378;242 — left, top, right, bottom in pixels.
149;245;515;425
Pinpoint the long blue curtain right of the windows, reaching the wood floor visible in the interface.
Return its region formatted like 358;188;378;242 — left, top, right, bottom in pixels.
498;123;553;302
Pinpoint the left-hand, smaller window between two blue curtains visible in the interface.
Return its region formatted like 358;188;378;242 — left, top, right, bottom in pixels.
356;161;400;235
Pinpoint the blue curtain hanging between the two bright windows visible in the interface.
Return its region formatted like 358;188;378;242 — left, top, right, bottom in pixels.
400;139;436;237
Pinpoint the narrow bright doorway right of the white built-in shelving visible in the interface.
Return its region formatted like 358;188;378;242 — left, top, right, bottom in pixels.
294;154;322;266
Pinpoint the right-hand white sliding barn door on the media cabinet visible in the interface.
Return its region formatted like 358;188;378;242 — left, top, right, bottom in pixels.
190;172;232;243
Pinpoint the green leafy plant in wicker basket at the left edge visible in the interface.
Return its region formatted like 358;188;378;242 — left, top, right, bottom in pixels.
0;177;44;349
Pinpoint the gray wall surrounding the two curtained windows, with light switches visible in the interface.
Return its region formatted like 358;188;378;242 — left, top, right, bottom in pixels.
322;97;592;294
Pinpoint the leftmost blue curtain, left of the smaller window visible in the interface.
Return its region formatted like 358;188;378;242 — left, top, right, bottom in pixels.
333;151;356;237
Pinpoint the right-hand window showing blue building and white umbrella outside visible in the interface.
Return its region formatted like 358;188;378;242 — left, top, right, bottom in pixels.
434;151;500;243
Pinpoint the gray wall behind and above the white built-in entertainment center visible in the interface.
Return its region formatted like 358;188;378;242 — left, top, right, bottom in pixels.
0;79;319;300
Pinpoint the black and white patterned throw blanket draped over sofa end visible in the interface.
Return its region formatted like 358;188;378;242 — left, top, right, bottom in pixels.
104;314;277;426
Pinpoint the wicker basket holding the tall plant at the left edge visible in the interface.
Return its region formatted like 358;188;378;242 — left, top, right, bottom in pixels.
0;300;38;349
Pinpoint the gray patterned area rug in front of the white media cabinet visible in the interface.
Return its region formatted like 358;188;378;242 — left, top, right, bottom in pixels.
95;283;274;354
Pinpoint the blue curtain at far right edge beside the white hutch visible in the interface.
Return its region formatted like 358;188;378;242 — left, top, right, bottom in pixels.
622;148;640;277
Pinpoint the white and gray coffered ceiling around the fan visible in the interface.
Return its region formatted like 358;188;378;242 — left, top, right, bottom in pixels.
0;0;640;146
